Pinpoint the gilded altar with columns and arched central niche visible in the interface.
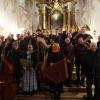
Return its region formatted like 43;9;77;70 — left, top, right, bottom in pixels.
37;0;75;31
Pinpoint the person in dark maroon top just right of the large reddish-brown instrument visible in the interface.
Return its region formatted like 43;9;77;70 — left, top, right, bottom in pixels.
63;38;75;86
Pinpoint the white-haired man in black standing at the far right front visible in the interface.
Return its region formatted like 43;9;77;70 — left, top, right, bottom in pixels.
85;43;100;100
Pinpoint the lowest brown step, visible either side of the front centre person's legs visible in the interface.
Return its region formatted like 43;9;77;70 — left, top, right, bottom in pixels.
14;92;85;100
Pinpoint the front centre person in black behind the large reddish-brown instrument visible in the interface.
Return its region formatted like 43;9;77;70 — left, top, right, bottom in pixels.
47;43;64;100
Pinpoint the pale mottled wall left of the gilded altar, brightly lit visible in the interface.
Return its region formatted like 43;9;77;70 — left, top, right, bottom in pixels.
0;0;39;37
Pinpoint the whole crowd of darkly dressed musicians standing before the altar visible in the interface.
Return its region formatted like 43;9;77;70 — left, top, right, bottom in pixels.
0;26;100;100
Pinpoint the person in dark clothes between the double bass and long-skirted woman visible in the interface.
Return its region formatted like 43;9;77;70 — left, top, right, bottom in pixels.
7;41;22;86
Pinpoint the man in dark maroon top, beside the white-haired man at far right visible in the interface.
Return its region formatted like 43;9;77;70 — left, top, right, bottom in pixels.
75;37;87;85
